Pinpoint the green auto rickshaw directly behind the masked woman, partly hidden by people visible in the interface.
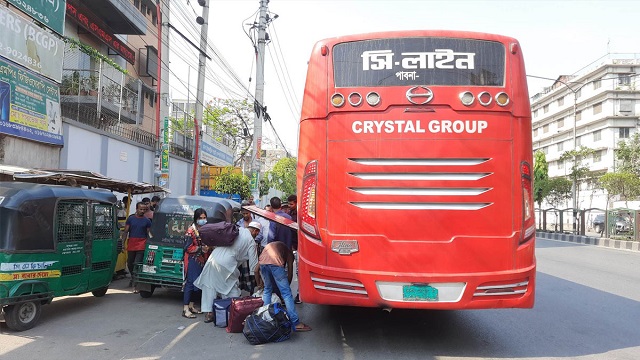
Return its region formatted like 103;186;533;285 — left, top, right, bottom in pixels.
133;195;240;298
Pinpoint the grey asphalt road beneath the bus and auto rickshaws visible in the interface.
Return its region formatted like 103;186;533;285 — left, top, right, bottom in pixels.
0;240;640;360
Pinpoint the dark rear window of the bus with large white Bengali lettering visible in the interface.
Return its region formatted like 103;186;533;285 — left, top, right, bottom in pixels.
333;37;505;87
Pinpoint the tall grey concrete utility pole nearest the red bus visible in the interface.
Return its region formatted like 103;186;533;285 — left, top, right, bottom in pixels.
251;0;269;200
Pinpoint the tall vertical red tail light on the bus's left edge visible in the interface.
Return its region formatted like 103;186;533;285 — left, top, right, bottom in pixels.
298;160;320;239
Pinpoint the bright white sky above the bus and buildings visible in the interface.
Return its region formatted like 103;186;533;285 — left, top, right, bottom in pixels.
171;0;640;155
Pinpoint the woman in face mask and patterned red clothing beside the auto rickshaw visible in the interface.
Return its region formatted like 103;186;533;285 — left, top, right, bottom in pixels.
182;208;211;319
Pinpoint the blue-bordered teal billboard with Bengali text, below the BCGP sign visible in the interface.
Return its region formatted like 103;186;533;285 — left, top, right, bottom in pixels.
0;59;63;145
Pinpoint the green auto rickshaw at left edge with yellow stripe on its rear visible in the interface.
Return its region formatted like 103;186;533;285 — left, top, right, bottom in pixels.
0;182;119;331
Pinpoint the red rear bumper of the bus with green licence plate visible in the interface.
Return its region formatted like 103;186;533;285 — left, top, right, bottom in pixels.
299;259;535;309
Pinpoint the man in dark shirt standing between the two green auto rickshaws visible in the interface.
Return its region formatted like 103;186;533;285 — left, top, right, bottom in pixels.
122;202;151;286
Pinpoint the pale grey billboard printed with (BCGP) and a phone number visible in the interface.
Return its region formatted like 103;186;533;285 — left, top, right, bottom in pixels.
0;6;64;82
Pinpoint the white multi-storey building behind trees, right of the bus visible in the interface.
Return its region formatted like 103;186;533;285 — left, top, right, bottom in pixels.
531;54;640;209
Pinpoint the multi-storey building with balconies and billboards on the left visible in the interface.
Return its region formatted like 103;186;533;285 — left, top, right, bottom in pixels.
0;0;200;195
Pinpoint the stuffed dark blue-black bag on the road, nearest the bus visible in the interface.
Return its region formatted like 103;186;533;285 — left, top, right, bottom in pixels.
242;303;293;345
